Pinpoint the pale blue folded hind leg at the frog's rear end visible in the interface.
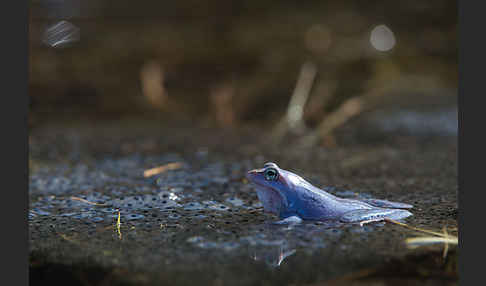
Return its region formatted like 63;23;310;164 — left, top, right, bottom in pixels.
339;208;412;225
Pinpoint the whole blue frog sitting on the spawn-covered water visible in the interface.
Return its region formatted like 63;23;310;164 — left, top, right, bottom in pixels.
246;163;413;225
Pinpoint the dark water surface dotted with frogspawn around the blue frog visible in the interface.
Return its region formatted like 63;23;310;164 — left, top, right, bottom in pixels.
29;113;457;285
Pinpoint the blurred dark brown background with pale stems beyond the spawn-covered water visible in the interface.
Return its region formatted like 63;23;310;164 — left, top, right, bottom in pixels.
29;0;458;146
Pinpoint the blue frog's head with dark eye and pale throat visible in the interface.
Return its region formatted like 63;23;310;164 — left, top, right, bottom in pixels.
246;163;297;215
